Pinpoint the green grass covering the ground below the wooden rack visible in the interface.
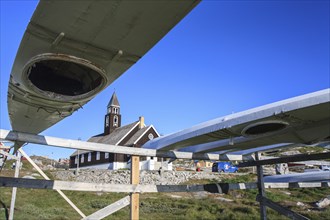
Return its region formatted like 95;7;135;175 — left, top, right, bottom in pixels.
0;168;330;220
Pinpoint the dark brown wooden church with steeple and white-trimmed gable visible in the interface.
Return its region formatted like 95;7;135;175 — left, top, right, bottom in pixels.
70;92;172;170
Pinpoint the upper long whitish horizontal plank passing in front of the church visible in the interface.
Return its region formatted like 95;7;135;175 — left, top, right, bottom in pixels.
0;129;238;161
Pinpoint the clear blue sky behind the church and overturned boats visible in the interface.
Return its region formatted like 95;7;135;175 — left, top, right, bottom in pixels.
0;0;330;158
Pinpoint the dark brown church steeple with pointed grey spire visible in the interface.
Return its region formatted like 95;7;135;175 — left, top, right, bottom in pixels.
104;92;121;135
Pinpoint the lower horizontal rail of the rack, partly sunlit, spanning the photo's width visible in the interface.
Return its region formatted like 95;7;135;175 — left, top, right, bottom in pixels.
0;177;330;193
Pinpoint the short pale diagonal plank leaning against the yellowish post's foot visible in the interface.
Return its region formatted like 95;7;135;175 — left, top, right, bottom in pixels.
83;196;130;220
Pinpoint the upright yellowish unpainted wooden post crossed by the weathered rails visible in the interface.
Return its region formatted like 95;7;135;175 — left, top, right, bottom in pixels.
130;156;140;220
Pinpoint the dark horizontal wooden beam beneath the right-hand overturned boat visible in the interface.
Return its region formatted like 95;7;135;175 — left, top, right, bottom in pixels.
238;152;330;167
